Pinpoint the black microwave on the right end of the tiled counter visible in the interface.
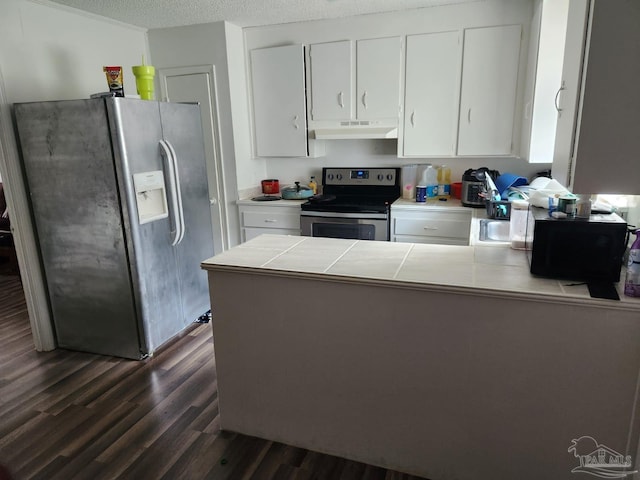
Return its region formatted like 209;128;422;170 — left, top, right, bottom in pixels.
526;207;627;283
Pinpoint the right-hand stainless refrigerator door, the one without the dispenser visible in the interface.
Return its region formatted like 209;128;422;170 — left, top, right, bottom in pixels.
159;103;213;324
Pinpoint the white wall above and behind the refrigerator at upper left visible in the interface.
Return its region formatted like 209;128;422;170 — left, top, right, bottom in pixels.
0;0;149;103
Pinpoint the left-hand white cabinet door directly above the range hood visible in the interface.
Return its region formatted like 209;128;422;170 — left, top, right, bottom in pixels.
309;40;353;120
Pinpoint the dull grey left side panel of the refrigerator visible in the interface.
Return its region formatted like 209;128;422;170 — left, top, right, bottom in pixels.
15;99;145;358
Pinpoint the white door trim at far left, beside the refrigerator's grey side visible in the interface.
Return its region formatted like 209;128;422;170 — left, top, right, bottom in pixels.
0;66;56;351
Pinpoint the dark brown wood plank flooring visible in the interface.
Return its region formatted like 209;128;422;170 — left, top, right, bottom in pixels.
0;275;430;480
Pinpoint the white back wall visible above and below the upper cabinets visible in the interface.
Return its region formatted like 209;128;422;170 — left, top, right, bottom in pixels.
238;0;550;189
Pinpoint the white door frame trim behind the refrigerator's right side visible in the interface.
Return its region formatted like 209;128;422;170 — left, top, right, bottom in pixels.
158;65;231;254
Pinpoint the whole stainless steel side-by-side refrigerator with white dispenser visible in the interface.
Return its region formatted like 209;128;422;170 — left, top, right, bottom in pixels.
15;98;213;359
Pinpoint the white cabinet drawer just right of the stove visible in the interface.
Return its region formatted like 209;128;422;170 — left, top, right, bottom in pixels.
392;212;471;241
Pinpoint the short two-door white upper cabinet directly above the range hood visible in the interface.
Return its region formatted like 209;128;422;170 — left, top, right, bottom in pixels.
309;37;402;121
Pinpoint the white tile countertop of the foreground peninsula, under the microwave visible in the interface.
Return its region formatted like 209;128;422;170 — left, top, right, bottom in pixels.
202;235;640;311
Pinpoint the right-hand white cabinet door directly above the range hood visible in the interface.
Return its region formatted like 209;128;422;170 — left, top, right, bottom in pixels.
356;37;402;120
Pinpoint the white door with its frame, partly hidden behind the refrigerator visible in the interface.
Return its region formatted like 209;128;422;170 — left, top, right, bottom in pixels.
158;65;229;254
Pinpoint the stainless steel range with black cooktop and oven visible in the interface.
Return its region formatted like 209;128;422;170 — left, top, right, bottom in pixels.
300;168;400;240
